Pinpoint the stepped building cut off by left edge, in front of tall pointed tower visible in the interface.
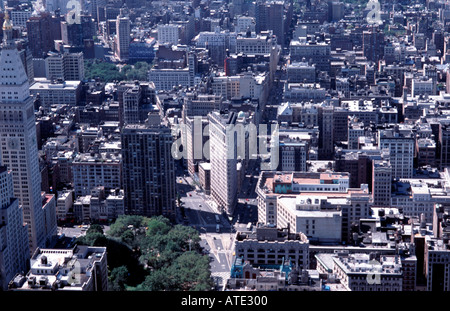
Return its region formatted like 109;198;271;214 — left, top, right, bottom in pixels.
0;166;30;291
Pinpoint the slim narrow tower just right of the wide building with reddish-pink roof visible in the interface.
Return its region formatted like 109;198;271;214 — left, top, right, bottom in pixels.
372;160;392;207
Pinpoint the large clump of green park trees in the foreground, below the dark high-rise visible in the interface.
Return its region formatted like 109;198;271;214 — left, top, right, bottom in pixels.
76;215;214;291
